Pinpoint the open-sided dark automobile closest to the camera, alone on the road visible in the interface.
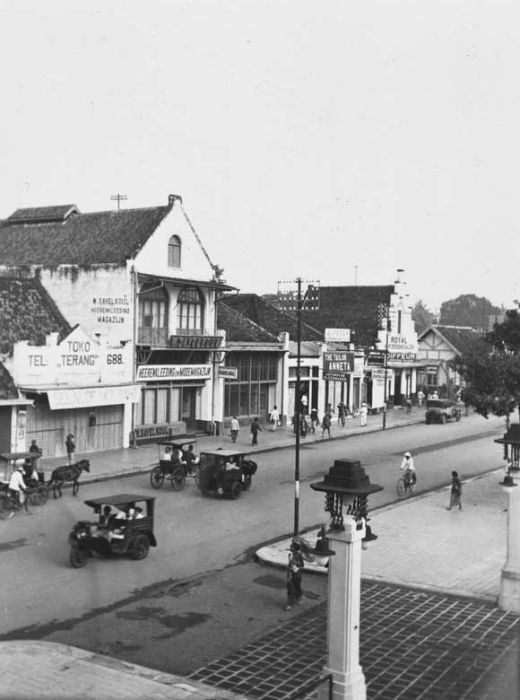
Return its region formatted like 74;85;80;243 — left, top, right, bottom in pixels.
69;493;157;569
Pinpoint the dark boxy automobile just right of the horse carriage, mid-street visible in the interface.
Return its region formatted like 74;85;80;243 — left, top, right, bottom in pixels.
198;449;257;499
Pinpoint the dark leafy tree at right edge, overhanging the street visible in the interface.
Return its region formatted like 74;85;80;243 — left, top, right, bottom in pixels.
451;310;520;418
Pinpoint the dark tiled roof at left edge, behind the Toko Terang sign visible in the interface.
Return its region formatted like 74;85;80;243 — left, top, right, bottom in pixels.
0;277;71;355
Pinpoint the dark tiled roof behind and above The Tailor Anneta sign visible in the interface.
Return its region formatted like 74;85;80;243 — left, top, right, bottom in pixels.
296;285;394;346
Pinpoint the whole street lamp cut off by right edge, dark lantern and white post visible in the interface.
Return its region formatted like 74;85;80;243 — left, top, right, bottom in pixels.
495;423;520;613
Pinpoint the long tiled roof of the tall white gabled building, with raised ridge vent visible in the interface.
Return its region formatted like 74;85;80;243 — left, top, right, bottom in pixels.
0;205;170;267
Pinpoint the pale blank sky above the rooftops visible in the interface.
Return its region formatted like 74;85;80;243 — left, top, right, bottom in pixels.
0;0;520;310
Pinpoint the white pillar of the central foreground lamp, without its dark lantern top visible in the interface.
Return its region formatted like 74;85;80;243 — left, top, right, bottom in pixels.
319;517;366;700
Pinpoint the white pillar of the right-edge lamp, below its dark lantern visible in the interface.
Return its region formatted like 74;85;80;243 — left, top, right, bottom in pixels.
498;482;520;614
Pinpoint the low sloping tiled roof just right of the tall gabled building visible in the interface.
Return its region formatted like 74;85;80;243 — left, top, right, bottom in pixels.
224;294;323;341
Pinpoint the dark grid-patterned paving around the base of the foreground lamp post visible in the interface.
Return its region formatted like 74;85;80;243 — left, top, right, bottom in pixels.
189;581;520;700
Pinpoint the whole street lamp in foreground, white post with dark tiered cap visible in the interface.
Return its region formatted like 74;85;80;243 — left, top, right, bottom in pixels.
311;459;383;700
